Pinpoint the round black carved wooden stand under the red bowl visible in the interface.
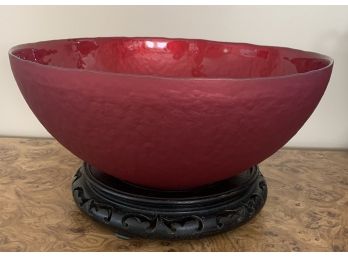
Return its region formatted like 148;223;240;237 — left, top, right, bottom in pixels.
72;163;267;239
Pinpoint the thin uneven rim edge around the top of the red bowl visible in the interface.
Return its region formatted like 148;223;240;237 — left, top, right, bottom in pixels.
8;36;334;81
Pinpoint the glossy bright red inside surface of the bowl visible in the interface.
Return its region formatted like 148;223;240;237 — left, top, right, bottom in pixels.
11;38;330;78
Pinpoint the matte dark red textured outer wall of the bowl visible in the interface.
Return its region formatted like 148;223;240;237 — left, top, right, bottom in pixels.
10;55;332;189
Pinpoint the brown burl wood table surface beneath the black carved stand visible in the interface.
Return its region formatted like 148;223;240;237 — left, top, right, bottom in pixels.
0;138;348;251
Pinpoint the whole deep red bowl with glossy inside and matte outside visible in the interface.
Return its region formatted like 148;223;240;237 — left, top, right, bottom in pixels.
9;37;333;189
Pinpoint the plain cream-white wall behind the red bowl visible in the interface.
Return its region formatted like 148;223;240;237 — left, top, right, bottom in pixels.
0;6;348;148
